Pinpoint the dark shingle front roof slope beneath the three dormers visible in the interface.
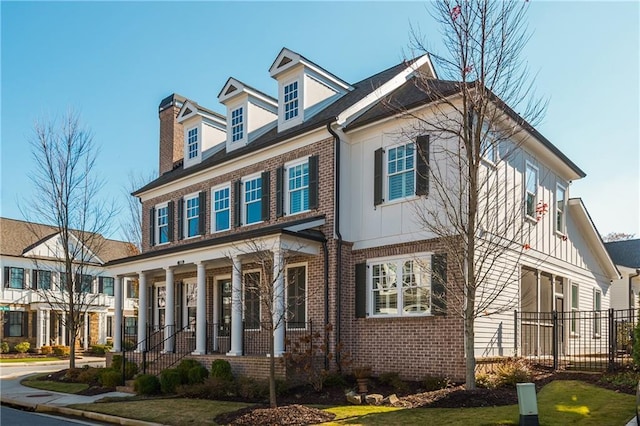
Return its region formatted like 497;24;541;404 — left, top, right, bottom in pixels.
133;62;407;195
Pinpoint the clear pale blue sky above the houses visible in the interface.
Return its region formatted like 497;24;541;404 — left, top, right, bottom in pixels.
0;0;640;238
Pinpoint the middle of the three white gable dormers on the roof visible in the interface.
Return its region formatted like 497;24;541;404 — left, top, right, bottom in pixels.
218;77;278;152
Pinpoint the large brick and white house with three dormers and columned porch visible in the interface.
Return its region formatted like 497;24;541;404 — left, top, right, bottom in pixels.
107;48;617;380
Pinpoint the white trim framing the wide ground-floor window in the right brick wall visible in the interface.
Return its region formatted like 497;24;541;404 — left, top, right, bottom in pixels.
367;252;434;318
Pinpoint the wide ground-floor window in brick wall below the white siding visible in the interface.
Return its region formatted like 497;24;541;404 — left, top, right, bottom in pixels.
369;259;431;316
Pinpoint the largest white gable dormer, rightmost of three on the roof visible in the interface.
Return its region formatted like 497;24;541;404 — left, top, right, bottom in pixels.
269;48;352;132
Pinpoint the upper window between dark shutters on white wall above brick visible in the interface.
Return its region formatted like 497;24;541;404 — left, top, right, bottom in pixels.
387;143;416;201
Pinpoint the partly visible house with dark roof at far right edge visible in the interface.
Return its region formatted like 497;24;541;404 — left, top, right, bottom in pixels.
604;239;640;309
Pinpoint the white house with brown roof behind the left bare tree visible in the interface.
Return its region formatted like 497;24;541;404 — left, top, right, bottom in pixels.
0;218;137;349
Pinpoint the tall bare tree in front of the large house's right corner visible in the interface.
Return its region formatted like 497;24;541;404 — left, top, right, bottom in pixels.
386;0;549;389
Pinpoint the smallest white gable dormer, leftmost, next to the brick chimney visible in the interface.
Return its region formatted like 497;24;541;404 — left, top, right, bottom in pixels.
177;100;227;168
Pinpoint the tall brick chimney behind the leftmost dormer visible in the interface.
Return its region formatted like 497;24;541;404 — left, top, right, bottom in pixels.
158;93;186;176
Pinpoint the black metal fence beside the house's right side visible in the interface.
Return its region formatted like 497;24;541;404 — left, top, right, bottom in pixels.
514;309;637;371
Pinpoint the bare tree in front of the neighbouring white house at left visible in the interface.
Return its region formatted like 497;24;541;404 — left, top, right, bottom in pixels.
22;112;115;368
